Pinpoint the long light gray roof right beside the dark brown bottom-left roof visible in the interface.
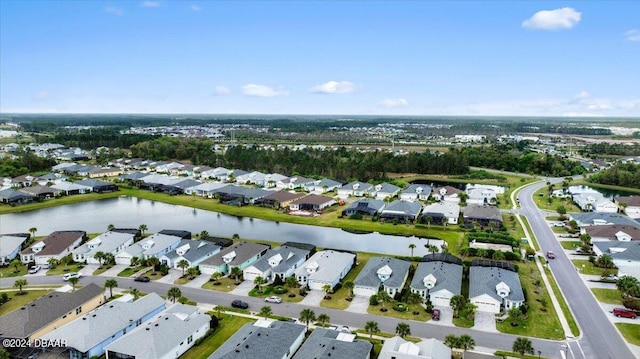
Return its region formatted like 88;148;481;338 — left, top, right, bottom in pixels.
42;293;165;353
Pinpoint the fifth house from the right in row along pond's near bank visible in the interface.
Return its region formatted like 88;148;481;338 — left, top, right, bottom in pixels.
242;245;310;282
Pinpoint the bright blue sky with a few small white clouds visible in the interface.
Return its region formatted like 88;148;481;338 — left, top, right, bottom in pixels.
0;0;640;116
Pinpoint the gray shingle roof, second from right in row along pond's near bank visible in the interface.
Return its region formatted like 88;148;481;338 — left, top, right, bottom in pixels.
411;261;462;294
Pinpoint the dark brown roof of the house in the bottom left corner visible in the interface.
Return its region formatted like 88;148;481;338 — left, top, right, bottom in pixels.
0;283;104;338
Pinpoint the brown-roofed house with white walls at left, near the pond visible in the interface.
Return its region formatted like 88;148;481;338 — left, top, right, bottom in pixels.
20;231;87;265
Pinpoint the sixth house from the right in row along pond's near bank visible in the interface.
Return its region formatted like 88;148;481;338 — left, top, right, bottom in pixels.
200;241;269;275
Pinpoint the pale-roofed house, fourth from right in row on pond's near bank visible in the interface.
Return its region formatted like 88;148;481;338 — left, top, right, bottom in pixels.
295;250;356;290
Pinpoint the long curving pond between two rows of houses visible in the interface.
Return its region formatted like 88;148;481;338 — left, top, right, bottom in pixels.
0;197;442;256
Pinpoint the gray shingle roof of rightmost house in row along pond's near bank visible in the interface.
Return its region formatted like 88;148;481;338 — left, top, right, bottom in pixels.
469;266;524;302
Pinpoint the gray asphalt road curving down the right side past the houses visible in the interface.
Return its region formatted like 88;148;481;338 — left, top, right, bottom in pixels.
518;179;635;359
